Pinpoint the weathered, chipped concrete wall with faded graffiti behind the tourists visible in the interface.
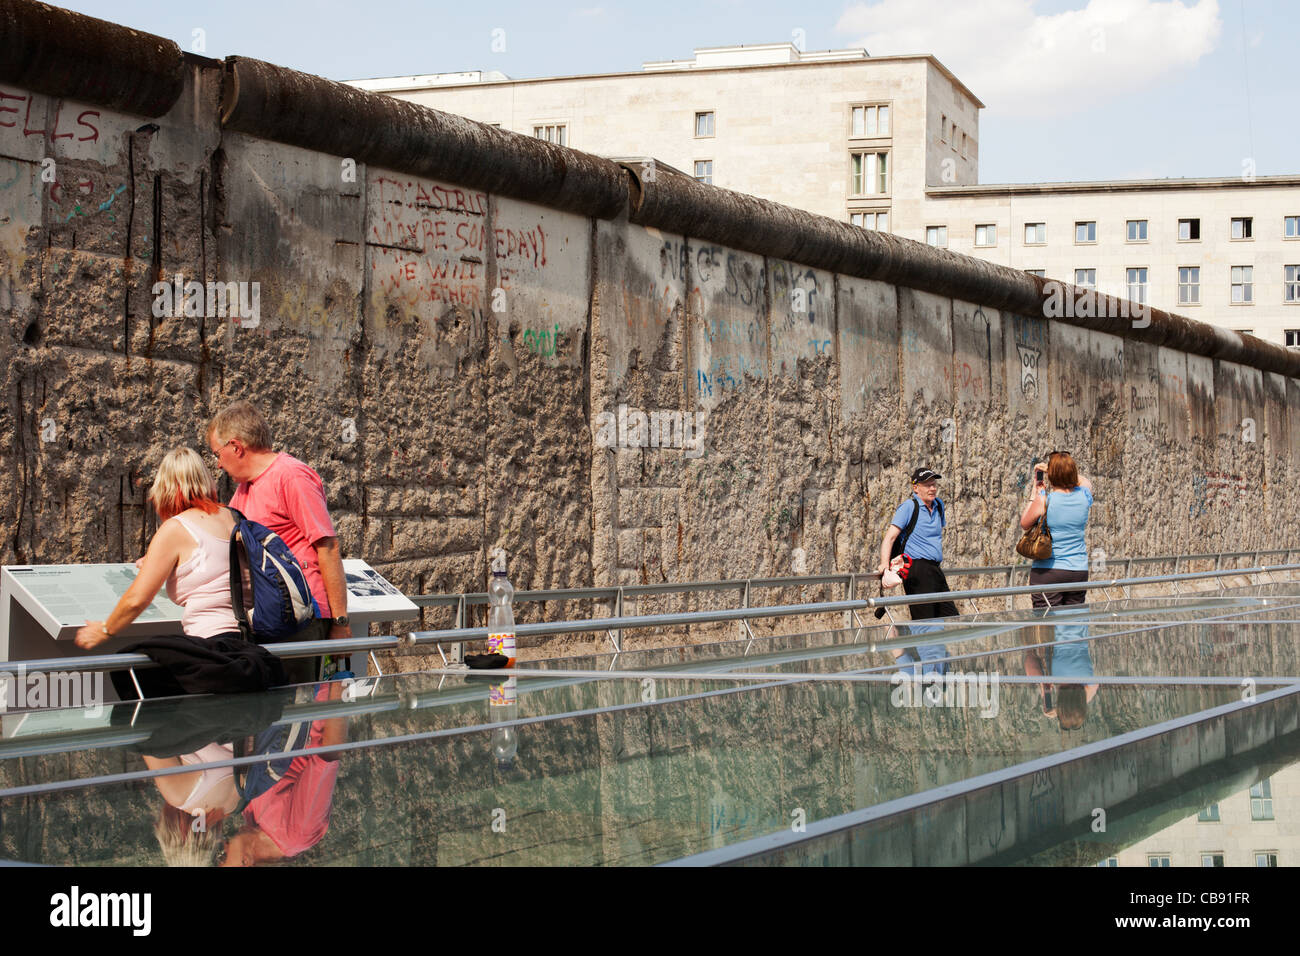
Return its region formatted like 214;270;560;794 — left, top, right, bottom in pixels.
0;41;1300;626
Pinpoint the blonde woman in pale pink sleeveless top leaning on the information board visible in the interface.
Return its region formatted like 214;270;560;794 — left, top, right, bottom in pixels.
77;449;239;650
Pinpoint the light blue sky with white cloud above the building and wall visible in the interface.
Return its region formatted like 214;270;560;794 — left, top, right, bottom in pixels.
60;0;1300;182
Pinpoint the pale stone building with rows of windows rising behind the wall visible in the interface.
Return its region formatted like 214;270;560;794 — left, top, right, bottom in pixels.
352;43;1300;346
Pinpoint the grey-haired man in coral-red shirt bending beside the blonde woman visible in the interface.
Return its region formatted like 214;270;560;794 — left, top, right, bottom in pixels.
208;402;352;660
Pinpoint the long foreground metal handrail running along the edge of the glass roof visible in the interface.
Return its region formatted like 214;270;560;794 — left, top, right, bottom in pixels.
0;551;1300;676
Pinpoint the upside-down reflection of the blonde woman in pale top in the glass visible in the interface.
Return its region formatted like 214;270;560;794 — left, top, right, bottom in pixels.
144;744;239;866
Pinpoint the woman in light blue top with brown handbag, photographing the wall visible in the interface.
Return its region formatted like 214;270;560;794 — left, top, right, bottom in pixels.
1021;451;1092;607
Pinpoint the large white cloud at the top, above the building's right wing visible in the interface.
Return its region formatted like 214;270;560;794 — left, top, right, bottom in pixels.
836;0;1223;116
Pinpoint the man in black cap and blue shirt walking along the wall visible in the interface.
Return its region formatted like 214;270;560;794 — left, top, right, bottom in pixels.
878;468;957;674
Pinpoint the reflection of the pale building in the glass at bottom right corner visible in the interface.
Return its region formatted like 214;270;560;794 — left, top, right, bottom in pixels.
1099;763;1300;866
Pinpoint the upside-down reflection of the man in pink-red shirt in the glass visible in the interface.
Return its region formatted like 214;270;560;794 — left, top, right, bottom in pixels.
221;682;347;866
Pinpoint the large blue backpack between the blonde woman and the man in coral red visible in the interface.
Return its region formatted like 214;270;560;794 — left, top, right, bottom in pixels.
230;509;320;644
